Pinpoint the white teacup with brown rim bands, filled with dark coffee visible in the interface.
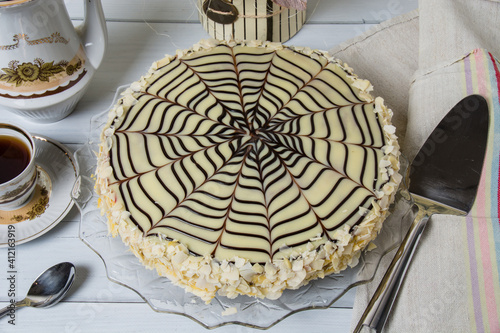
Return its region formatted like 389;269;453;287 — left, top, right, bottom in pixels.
0;123;38;211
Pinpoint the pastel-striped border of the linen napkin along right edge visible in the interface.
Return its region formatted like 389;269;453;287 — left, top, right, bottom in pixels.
459;49;500;332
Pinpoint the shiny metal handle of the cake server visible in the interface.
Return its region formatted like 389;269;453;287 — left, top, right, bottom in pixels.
354;204;432;333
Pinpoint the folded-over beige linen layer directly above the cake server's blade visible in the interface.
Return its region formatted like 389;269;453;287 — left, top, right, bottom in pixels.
404;0;500;158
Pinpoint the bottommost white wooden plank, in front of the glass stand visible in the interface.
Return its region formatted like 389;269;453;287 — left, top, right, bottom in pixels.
0;302;352;333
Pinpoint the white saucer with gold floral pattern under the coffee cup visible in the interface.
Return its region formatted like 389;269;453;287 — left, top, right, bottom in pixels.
0;135;78;247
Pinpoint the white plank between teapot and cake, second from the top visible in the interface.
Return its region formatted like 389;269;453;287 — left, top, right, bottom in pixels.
0;22;371;143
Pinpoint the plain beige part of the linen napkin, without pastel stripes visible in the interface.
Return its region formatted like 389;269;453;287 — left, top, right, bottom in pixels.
331;0;500;333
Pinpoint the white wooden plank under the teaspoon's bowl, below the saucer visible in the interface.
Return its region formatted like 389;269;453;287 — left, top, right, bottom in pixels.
0;221;143;302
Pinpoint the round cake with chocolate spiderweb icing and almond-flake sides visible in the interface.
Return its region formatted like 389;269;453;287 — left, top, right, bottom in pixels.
96;40;401;302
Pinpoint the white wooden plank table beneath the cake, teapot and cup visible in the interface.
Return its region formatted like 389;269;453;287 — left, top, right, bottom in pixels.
0;0;417;333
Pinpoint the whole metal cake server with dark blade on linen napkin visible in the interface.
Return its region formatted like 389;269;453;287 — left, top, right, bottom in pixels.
354;95;489;332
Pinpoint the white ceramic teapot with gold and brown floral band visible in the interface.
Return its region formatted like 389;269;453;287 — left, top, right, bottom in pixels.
0;0;107;123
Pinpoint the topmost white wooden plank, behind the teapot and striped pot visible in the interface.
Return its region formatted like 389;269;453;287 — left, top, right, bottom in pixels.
65;0;418;24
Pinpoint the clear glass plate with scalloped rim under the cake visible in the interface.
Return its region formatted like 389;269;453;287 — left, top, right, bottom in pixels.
72;87;412;329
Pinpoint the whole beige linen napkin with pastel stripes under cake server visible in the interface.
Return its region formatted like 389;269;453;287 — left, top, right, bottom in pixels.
332;0;500;332
